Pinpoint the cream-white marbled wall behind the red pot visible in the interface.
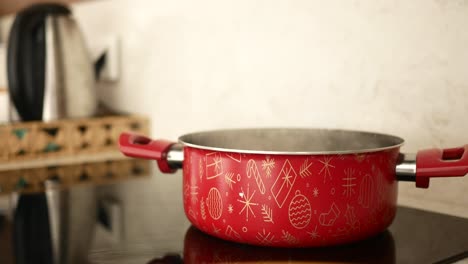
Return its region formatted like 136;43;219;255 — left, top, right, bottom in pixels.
74;0;468;216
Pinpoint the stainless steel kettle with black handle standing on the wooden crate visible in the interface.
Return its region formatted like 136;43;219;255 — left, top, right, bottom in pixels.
7;4;97;121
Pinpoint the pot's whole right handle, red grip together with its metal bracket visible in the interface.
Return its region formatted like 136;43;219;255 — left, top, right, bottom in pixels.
396;145;468;188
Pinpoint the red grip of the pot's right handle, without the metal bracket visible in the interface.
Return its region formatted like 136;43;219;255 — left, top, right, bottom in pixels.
416;145;468;188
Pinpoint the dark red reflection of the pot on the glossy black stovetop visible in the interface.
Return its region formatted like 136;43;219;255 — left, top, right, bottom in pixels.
149;226;396;264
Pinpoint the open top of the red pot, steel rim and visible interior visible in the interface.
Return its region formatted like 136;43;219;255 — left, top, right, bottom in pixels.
179;128;404;155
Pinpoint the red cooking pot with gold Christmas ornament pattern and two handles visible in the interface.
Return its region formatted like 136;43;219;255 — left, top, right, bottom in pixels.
119;129;468;247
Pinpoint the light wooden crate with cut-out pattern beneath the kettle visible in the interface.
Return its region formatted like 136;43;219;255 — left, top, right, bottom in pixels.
0;115;149;171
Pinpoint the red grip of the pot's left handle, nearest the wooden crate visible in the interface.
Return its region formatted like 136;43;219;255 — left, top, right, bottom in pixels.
119;132;176;173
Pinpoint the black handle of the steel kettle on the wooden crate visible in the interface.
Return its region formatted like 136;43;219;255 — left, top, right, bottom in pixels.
7;4;71;121
